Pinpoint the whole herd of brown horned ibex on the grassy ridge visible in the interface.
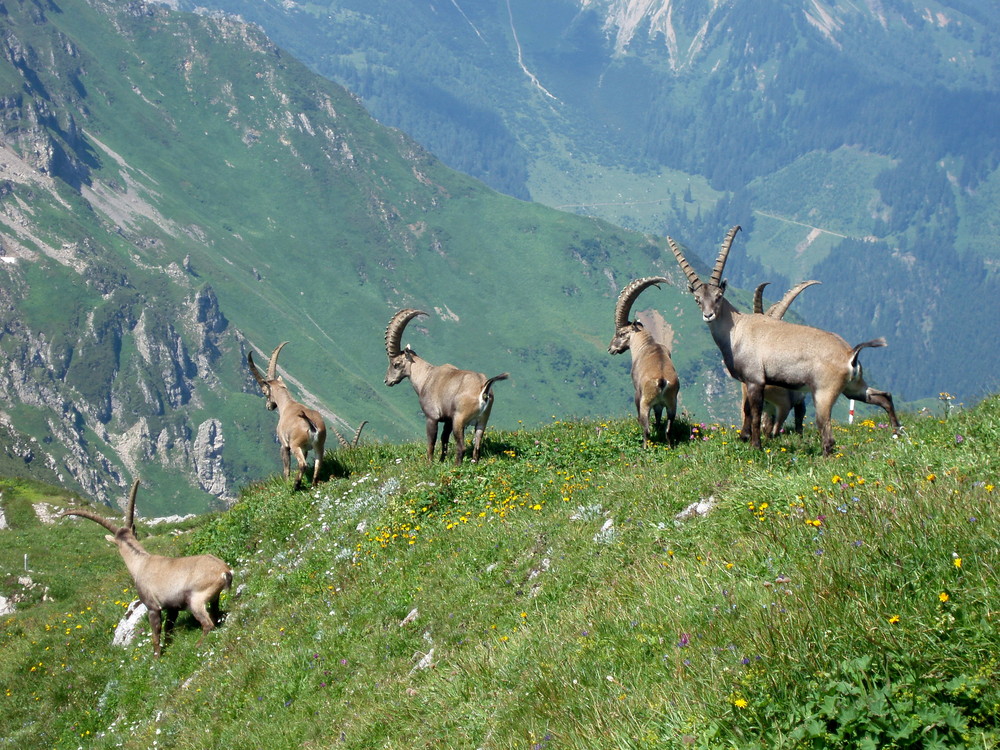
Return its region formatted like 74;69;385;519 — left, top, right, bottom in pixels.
52;226;900;657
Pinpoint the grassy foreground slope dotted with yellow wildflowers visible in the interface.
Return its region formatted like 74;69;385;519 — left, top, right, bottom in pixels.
0;396;1000;750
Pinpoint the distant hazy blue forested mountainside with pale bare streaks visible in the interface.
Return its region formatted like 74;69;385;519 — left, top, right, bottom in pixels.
193;0;1000;406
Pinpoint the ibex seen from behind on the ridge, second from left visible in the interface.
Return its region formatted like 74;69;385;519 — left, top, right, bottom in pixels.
247;341;326;489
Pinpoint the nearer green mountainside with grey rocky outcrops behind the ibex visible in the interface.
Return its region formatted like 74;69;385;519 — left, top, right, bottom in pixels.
0;0;745;515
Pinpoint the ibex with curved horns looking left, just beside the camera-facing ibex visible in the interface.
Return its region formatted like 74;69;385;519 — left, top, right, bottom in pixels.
608;276;680;448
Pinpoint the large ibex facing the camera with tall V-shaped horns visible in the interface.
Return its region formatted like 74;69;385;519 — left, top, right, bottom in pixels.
667;226;900;456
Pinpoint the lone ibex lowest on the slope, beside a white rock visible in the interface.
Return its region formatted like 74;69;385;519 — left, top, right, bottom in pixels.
60;479;233;657
